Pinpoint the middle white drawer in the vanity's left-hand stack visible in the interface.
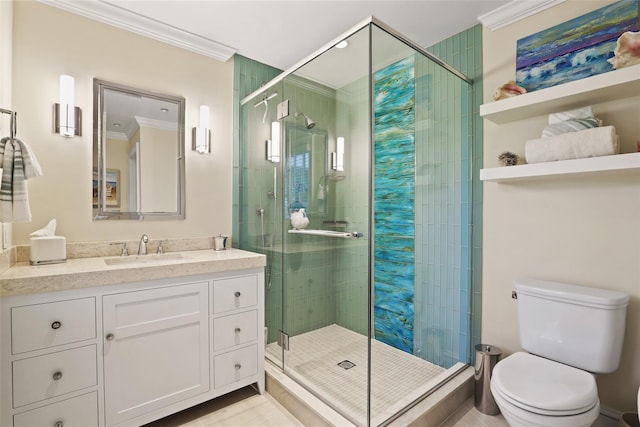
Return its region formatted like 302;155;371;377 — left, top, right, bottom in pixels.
13;345;98;408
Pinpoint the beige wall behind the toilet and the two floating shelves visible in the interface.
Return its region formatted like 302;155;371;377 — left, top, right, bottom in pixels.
482;0;640;411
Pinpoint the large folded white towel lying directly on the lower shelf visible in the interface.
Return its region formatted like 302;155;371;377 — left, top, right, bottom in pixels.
524;126;620;163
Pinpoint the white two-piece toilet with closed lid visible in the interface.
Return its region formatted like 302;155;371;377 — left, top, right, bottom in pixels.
491;278;629;427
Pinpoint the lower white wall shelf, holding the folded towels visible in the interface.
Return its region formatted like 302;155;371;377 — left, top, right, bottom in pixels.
480;153;640;182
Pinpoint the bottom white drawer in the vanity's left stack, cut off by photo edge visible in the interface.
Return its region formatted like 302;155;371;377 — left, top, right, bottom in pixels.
13;392;98;427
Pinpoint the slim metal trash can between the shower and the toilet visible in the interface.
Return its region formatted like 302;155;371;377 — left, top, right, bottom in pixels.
473;344;502;415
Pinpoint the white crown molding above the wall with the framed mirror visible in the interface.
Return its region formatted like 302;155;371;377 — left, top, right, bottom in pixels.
38;0;237;62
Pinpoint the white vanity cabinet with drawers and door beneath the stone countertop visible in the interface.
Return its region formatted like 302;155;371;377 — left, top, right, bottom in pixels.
0;268;264;427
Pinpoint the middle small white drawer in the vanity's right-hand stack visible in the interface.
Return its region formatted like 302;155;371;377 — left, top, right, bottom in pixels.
213;310;258;351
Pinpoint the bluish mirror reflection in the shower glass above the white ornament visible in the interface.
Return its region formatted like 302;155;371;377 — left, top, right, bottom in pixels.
284;126;328;217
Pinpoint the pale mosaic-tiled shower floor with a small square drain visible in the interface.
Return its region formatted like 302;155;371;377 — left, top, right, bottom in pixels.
267;324;463;425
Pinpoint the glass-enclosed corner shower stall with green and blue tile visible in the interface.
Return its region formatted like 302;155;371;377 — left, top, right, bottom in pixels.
236;18;473;426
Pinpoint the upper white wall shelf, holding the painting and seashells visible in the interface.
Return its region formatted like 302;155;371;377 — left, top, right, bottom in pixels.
480;65;640;124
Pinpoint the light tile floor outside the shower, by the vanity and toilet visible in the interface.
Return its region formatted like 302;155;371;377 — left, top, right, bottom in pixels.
145;387;618;427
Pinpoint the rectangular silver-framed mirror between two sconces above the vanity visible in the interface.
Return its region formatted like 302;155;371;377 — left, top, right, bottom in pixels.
93;79;185;220
